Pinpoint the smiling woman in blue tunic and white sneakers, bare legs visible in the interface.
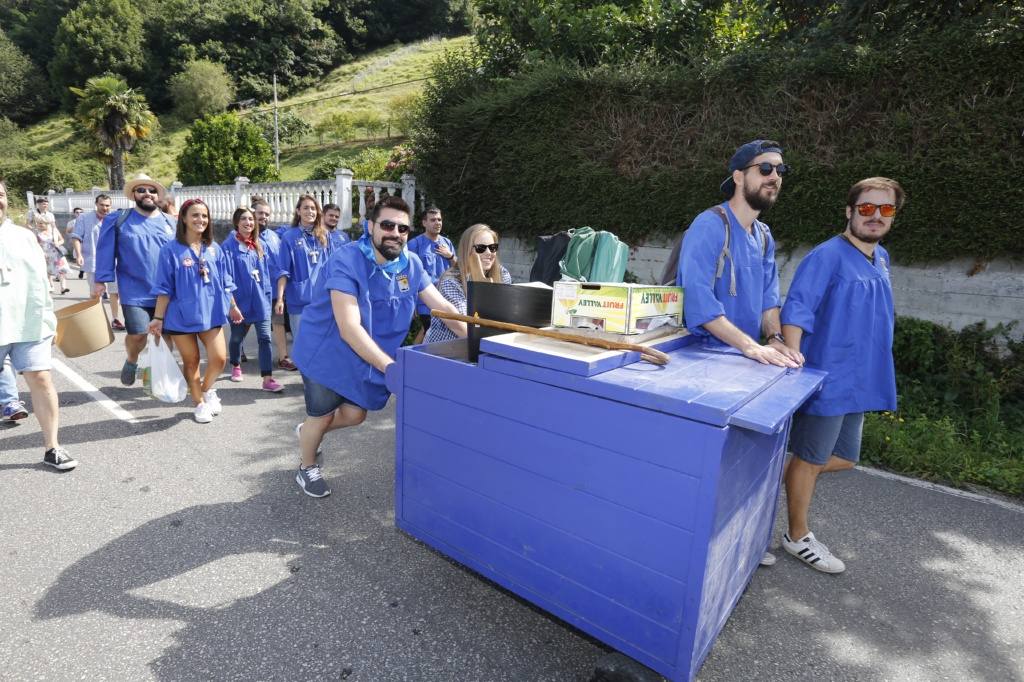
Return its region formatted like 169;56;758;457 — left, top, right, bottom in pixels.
148;199;243;424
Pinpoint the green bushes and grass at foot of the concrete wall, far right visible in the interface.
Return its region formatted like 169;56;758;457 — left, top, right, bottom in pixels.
863;317;1024;498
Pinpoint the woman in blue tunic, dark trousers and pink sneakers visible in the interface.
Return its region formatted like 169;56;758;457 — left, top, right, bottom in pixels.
220;208;285;393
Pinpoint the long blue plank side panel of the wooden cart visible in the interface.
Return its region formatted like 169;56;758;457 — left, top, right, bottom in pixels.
396;353;725;679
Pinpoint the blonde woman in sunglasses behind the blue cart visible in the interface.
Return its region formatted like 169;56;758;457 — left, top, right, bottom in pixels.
424;222;512;343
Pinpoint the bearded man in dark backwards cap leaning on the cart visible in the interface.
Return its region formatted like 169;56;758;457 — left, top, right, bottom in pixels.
676;139;804;565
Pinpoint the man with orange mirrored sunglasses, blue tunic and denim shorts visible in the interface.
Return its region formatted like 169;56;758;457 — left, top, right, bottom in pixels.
781;177;904;573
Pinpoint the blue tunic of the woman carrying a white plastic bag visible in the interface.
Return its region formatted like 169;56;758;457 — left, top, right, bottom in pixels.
151;240;234;332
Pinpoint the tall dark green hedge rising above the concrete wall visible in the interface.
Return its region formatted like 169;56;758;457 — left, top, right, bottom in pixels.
415;26;1024;262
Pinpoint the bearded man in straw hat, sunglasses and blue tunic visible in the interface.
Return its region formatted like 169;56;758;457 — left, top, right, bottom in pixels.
92;173;174;386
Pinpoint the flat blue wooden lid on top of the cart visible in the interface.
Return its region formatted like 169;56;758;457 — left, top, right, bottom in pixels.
479;340;825;433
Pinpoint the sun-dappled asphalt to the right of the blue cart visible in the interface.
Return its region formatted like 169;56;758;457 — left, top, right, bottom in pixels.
699;471;1024;682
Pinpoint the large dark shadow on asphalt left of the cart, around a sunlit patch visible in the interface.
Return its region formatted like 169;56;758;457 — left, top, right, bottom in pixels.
34;409;603;681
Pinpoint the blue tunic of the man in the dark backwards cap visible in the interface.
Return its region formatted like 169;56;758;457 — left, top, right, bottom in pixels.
676;203;779;340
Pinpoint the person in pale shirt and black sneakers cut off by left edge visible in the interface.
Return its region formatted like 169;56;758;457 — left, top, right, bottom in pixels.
0;180;78;471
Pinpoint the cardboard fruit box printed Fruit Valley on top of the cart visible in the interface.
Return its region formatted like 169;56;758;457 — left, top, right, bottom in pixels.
551;282;683;334
